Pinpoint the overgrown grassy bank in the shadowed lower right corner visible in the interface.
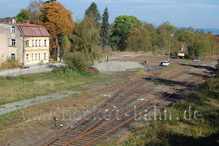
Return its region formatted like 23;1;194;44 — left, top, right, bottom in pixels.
100;67;219;146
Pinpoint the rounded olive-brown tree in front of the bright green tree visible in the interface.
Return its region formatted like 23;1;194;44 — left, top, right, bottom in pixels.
126;28;151;51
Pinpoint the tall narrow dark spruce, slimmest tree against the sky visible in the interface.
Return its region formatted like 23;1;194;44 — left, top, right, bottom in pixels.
100;7;109;50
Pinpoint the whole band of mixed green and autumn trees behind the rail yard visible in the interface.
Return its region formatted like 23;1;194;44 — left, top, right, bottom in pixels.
2;0;219;69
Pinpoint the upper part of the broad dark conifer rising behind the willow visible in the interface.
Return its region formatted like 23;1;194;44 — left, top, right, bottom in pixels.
85;2;101;26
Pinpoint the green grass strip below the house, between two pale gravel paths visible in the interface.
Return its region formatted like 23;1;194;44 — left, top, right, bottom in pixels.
0;69;111;105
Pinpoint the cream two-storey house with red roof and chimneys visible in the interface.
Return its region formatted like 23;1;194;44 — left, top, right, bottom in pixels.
0;19;50;66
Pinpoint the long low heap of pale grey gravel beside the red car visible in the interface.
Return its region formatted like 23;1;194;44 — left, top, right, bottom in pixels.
94;61;144;72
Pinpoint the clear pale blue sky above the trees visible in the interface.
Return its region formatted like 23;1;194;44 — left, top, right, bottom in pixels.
0;0;219;29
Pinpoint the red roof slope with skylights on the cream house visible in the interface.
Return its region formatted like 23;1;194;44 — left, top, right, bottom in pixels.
15;23;50;37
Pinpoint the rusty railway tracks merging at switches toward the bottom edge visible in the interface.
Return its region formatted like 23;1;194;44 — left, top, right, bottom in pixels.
46;70;210;145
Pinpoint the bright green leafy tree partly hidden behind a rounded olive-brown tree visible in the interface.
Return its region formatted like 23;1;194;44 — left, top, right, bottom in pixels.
111;15;141;50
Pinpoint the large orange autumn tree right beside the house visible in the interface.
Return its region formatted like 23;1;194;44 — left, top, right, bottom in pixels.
38;2;74;61
